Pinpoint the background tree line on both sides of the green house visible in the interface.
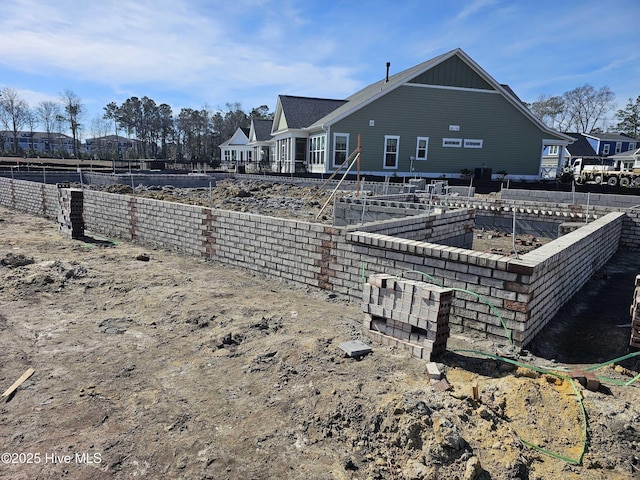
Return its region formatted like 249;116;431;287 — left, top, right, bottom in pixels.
0;84;640;162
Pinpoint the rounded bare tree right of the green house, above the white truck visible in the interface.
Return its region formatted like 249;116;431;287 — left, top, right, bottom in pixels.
562;84;615;133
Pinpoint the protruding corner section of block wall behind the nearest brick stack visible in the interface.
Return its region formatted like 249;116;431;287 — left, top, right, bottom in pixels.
347;213;624;345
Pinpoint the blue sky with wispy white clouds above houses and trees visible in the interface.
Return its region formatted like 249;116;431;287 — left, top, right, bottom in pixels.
0;0;640;135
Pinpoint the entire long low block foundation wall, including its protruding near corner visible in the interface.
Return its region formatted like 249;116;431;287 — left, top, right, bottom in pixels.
0;178;640;345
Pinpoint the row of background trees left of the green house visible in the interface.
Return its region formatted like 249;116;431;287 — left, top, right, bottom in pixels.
0;87;273;163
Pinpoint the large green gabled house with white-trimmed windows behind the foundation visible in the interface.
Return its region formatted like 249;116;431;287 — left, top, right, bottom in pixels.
271;49;574;179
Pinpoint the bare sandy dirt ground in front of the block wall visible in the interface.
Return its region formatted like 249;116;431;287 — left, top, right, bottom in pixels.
0;203;640;480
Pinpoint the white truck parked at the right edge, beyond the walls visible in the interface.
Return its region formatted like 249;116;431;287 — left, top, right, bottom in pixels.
563;158;640;188
